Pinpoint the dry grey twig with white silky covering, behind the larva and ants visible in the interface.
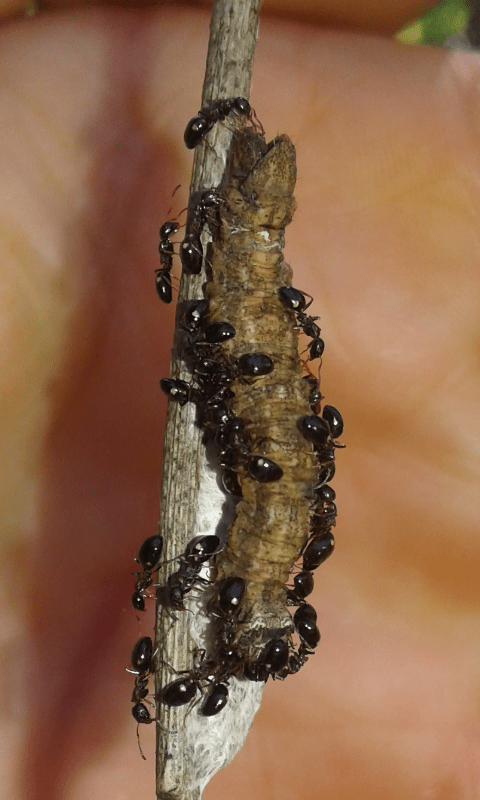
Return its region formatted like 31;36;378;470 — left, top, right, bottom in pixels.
155;0;263;800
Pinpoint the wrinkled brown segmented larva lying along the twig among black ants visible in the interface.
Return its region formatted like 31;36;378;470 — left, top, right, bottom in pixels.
205;129;317;659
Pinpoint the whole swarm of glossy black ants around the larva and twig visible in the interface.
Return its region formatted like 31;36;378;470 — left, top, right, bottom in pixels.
131;98;343;756
